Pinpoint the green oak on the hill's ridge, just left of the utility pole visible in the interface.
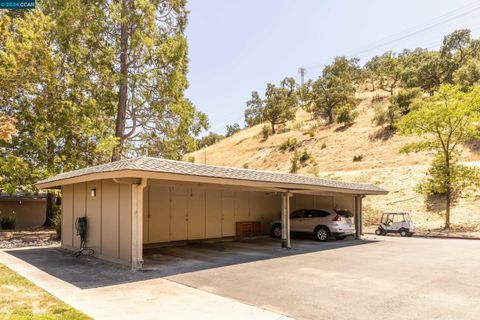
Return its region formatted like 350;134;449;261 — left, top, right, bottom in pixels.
245;78;299;134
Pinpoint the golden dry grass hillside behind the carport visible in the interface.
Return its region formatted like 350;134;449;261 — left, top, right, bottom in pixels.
188;92;480;231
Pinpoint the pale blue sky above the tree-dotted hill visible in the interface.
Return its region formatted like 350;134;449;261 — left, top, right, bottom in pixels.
186;0;480;133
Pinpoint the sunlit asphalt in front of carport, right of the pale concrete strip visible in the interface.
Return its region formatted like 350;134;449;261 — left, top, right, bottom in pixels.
166;237;480;320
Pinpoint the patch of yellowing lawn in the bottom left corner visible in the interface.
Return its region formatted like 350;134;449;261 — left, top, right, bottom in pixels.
0;265;91;320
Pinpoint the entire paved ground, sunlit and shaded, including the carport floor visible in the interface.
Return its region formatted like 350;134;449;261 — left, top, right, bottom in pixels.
0;237;480;319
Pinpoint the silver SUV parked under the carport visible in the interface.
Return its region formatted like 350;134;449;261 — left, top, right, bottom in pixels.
271;209;355;241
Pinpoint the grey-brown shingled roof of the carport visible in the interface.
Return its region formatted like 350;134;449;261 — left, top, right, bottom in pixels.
37;157;387;194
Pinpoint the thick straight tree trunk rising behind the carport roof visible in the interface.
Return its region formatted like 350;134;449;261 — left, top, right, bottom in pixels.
112;0;129;161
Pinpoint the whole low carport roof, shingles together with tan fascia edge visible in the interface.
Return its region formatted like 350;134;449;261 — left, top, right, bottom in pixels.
37;157;387;195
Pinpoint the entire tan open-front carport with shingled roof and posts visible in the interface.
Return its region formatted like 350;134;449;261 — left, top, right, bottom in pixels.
37;157;387;270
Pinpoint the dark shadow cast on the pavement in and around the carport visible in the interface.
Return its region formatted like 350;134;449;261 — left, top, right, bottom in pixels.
5;238;374;289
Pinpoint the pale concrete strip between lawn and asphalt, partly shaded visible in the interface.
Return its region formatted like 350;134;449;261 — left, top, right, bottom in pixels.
0;240;300;320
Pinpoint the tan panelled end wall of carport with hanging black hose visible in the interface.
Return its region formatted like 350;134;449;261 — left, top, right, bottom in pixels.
62;179;132;265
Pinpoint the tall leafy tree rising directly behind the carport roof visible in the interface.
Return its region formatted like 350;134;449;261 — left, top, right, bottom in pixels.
44;0;208;160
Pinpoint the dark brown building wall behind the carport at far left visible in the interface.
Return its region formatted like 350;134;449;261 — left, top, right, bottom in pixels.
0;200;47;229
